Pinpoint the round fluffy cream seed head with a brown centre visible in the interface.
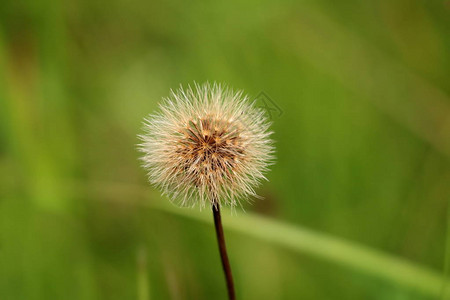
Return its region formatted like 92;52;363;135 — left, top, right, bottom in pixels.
139;83;273;207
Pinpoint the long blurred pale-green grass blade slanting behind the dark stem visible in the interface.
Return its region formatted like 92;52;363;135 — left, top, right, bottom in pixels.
88;183;444;297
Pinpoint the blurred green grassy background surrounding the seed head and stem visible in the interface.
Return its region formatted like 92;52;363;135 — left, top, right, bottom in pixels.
0;0;450;300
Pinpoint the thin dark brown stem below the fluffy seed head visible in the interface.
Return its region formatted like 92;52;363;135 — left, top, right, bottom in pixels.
212;203;236;300
